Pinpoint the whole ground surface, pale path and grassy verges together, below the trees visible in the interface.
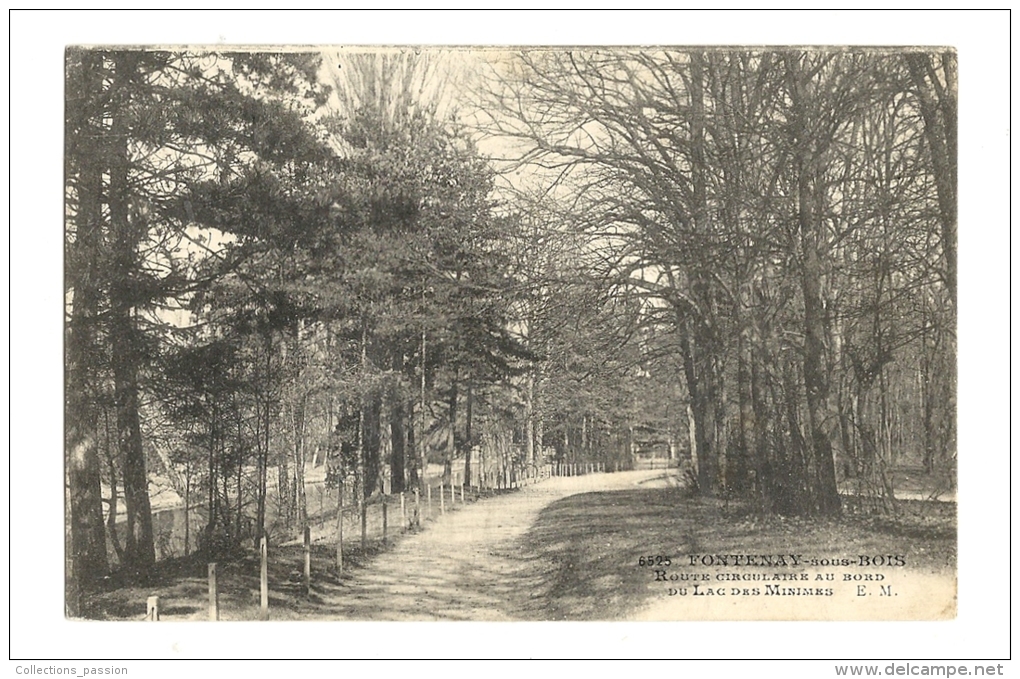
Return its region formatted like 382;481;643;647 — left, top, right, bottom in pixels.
90;469;956;621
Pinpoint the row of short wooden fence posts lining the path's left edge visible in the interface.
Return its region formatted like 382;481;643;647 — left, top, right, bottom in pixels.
146;462;607;622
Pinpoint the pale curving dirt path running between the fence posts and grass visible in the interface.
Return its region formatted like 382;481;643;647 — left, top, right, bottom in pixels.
320;470;663;621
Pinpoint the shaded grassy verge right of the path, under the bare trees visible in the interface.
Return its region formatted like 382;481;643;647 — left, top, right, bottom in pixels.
510;488;956;620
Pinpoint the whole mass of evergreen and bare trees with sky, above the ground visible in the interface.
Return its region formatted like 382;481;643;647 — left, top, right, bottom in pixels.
64;48;957;612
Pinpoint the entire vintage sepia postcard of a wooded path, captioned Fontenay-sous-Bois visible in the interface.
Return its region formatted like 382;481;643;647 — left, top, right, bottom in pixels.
63;45;958;622
